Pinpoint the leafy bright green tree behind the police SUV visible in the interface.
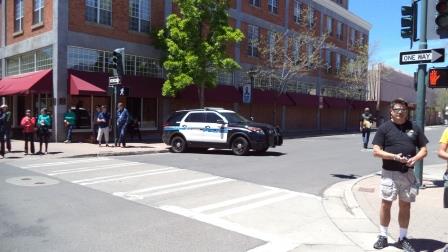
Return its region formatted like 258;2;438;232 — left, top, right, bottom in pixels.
158;0;244;107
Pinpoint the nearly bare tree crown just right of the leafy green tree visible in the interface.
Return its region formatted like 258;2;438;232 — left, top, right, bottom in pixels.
249;9;333;95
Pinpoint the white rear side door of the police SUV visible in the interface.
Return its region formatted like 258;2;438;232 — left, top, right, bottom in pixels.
180;112;205;142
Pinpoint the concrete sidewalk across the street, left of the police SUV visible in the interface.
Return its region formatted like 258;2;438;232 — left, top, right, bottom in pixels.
0;140;169;160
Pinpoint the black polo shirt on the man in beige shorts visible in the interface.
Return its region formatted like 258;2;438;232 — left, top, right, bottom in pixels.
372;120;429;171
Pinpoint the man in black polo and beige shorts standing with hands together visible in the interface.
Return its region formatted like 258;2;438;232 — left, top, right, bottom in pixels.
372;98;428;252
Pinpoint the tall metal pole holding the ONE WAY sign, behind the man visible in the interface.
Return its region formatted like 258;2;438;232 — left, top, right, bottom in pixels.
414;0;428;187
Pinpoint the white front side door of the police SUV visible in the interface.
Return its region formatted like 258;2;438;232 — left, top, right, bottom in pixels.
204;111;228;143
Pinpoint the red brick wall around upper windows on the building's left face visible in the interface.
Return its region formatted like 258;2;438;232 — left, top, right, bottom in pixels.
5;0;53;45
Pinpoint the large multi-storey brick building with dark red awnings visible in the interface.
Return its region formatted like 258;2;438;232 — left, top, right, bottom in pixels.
0;0;371;140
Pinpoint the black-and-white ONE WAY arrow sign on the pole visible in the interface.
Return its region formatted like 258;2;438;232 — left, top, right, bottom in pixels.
400;48;445;65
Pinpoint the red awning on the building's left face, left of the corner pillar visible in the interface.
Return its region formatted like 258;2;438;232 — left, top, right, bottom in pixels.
0;69;53;95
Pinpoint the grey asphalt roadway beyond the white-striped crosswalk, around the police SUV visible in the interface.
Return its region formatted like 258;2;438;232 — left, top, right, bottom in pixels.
118;126;444;195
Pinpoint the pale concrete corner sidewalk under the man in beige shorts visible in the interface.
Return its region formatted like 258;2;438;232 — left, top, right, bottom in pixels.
323;164;448;252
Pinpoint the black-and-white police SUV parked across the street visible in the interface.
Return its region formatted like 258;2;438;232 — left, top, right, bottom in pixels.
162;108;283;156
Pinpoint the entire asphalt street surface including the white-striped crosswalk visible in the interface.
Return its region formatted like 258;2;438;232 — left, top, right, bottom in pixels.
0;127;444;251
